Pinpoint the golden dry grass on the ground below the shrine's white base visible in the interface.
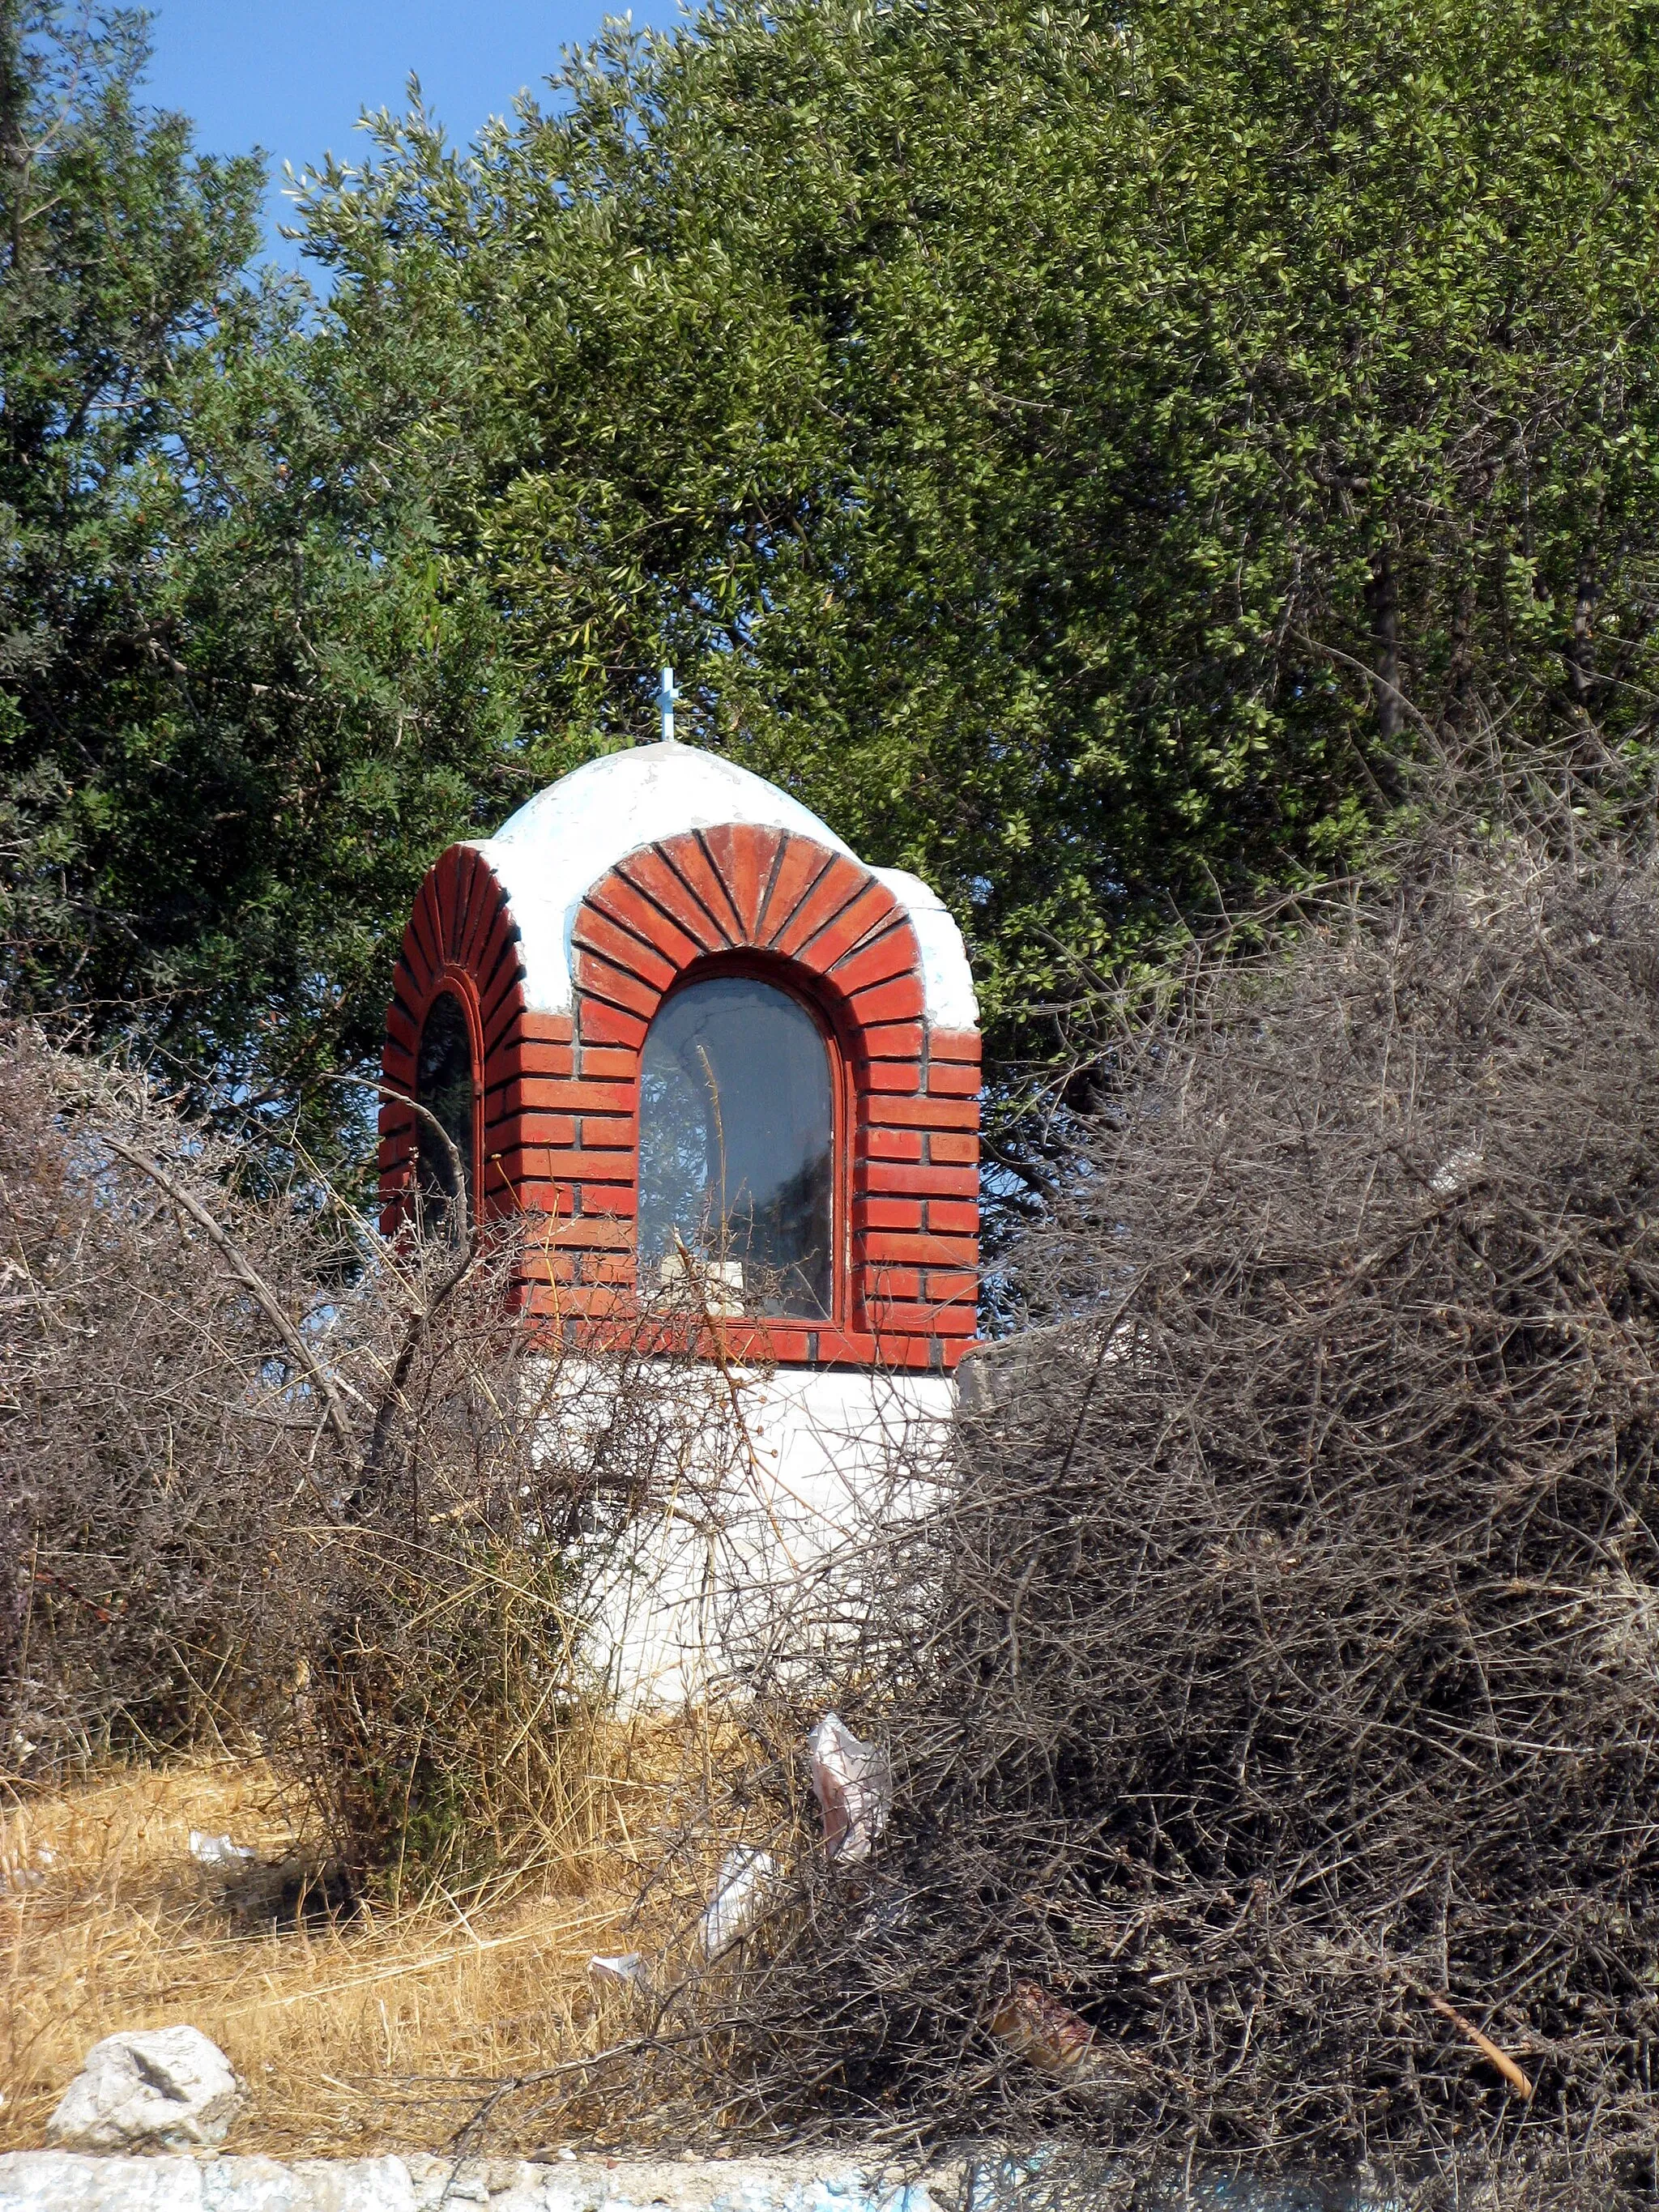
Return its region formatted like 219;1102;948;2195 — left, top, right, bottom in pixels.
0;1725;725;2154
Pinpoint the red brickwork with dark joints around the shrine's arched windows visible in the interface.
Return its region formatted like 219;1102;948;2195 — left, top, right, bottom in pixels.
381;823;980;1367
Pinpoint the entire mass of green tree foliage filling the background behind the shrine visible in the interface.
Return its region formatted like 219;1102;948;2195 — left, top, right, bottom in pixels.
0;0;1659;1176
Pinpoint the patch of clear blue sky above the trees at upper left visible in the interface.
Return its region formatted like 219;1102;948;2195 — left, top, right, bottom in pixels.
151;0;679;259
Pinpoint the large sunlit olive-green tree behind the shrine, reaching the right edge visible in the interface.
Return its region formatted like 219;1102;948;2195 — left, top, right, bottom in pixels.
292;0;1659;1079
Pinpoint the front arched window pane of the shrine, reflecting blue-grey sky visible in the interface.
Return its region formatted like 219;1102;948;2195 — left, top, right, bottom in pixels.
639;975;834;1320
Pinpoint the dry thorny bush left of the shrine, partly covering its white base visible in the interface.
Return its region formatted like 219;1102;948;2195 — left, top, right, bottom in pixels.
0;1031;747;1891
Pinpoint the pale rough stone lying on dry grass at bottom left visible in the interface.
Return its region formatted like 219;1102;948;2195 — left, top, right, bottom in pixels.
46;2028;241;2152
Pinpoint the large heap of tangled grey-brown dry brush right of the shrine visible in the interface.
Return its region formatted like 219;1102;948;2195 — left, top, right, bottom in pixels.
524;838;1659;2203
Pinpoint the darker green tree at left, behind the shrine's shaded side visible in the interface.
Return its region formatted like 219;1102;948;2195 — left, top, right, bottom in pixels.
0;0;522;1167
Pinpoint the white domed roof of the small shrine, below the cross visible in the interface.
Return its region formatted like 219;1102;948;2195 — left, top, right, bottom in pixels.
476;739;980;1029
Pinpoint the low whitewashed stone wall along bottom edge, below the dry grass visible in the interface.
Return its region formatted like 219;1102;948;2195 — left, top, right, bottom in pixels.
0;2150;962;2212
